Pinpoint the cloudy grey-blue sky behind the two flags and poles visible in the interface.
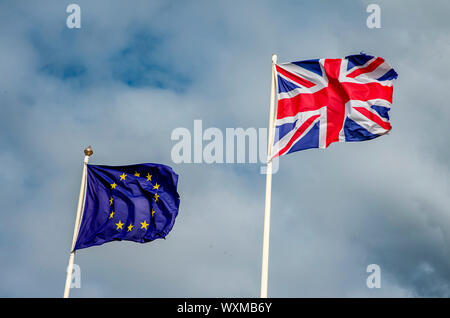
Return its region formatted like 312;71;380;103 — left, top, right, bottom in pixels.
0;0;450;297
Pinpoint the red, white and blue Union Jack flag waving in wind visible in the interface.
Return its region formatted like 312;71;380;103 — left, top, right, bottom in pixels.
271;54;398;158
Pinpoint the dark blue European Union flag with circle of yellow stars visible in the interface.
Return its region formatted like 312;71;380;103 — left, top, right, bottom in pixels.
74;163;180;250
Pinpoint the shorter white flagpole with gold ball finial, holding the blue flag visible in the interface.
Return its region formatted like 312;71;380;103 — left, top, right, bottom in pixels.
64;146;94;298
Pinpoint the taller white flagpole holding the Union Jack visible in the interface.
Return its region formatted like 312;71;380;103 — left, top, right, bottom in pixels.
261;54;277;298
